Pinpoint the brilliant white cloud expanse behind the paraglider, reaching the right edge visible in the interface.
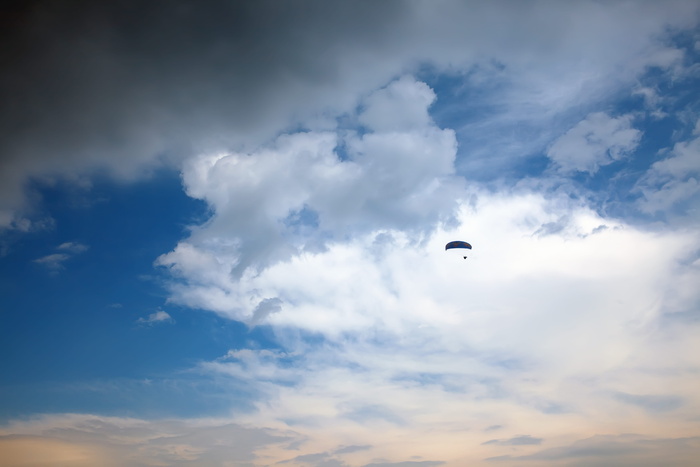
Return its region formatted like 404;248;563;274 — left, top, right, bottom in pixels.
160;187;700;465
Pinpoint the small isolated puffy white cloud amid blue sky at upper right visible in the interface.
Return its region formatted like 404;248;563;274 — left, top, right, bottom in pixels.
547;112;642;175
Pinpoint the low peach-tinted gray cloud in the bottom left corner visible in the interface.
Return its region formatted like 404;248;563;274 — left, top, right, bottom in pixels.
0;414;295;466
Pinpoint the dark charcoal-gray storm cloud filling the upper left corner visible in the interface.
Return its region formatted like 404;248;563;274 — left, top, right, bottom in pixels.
0;0;408;223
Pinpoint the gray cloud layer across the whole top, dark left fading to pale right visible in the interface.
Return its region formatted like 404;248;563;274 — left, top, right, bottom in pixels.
0;1;697;227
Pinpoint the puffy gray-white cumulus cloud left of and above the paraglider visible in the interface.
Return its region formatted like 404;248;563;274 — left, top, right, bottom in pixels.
158;78;463;278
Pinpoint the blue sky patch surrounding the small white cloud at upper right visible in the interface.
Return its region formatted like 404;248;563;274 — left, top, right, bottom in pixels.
421;36;700;229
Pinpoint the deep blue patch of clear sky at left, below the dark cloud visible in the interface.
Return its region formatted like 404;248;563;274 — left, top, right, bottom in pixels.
0;172;272;416
